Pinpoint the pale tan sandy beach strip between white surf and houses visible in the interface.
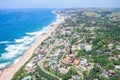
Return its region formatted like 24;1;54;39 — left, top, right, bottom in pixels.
0;14;64;80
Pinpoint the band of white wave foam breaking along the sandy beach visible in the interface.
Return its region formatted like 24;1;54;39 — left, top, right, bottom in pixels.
0;12;60;69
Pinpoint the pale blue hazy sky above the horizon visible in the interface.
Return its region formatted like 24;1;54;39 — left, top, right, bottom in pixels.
0;0;120;8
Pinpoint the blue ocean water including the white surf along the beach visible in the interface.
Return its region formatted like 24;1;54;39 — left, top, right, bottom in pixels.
0;9;56;69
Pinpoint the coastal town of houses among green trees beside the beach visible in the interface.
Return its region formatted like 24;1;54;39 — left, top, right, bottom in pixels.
12;8;120;80
